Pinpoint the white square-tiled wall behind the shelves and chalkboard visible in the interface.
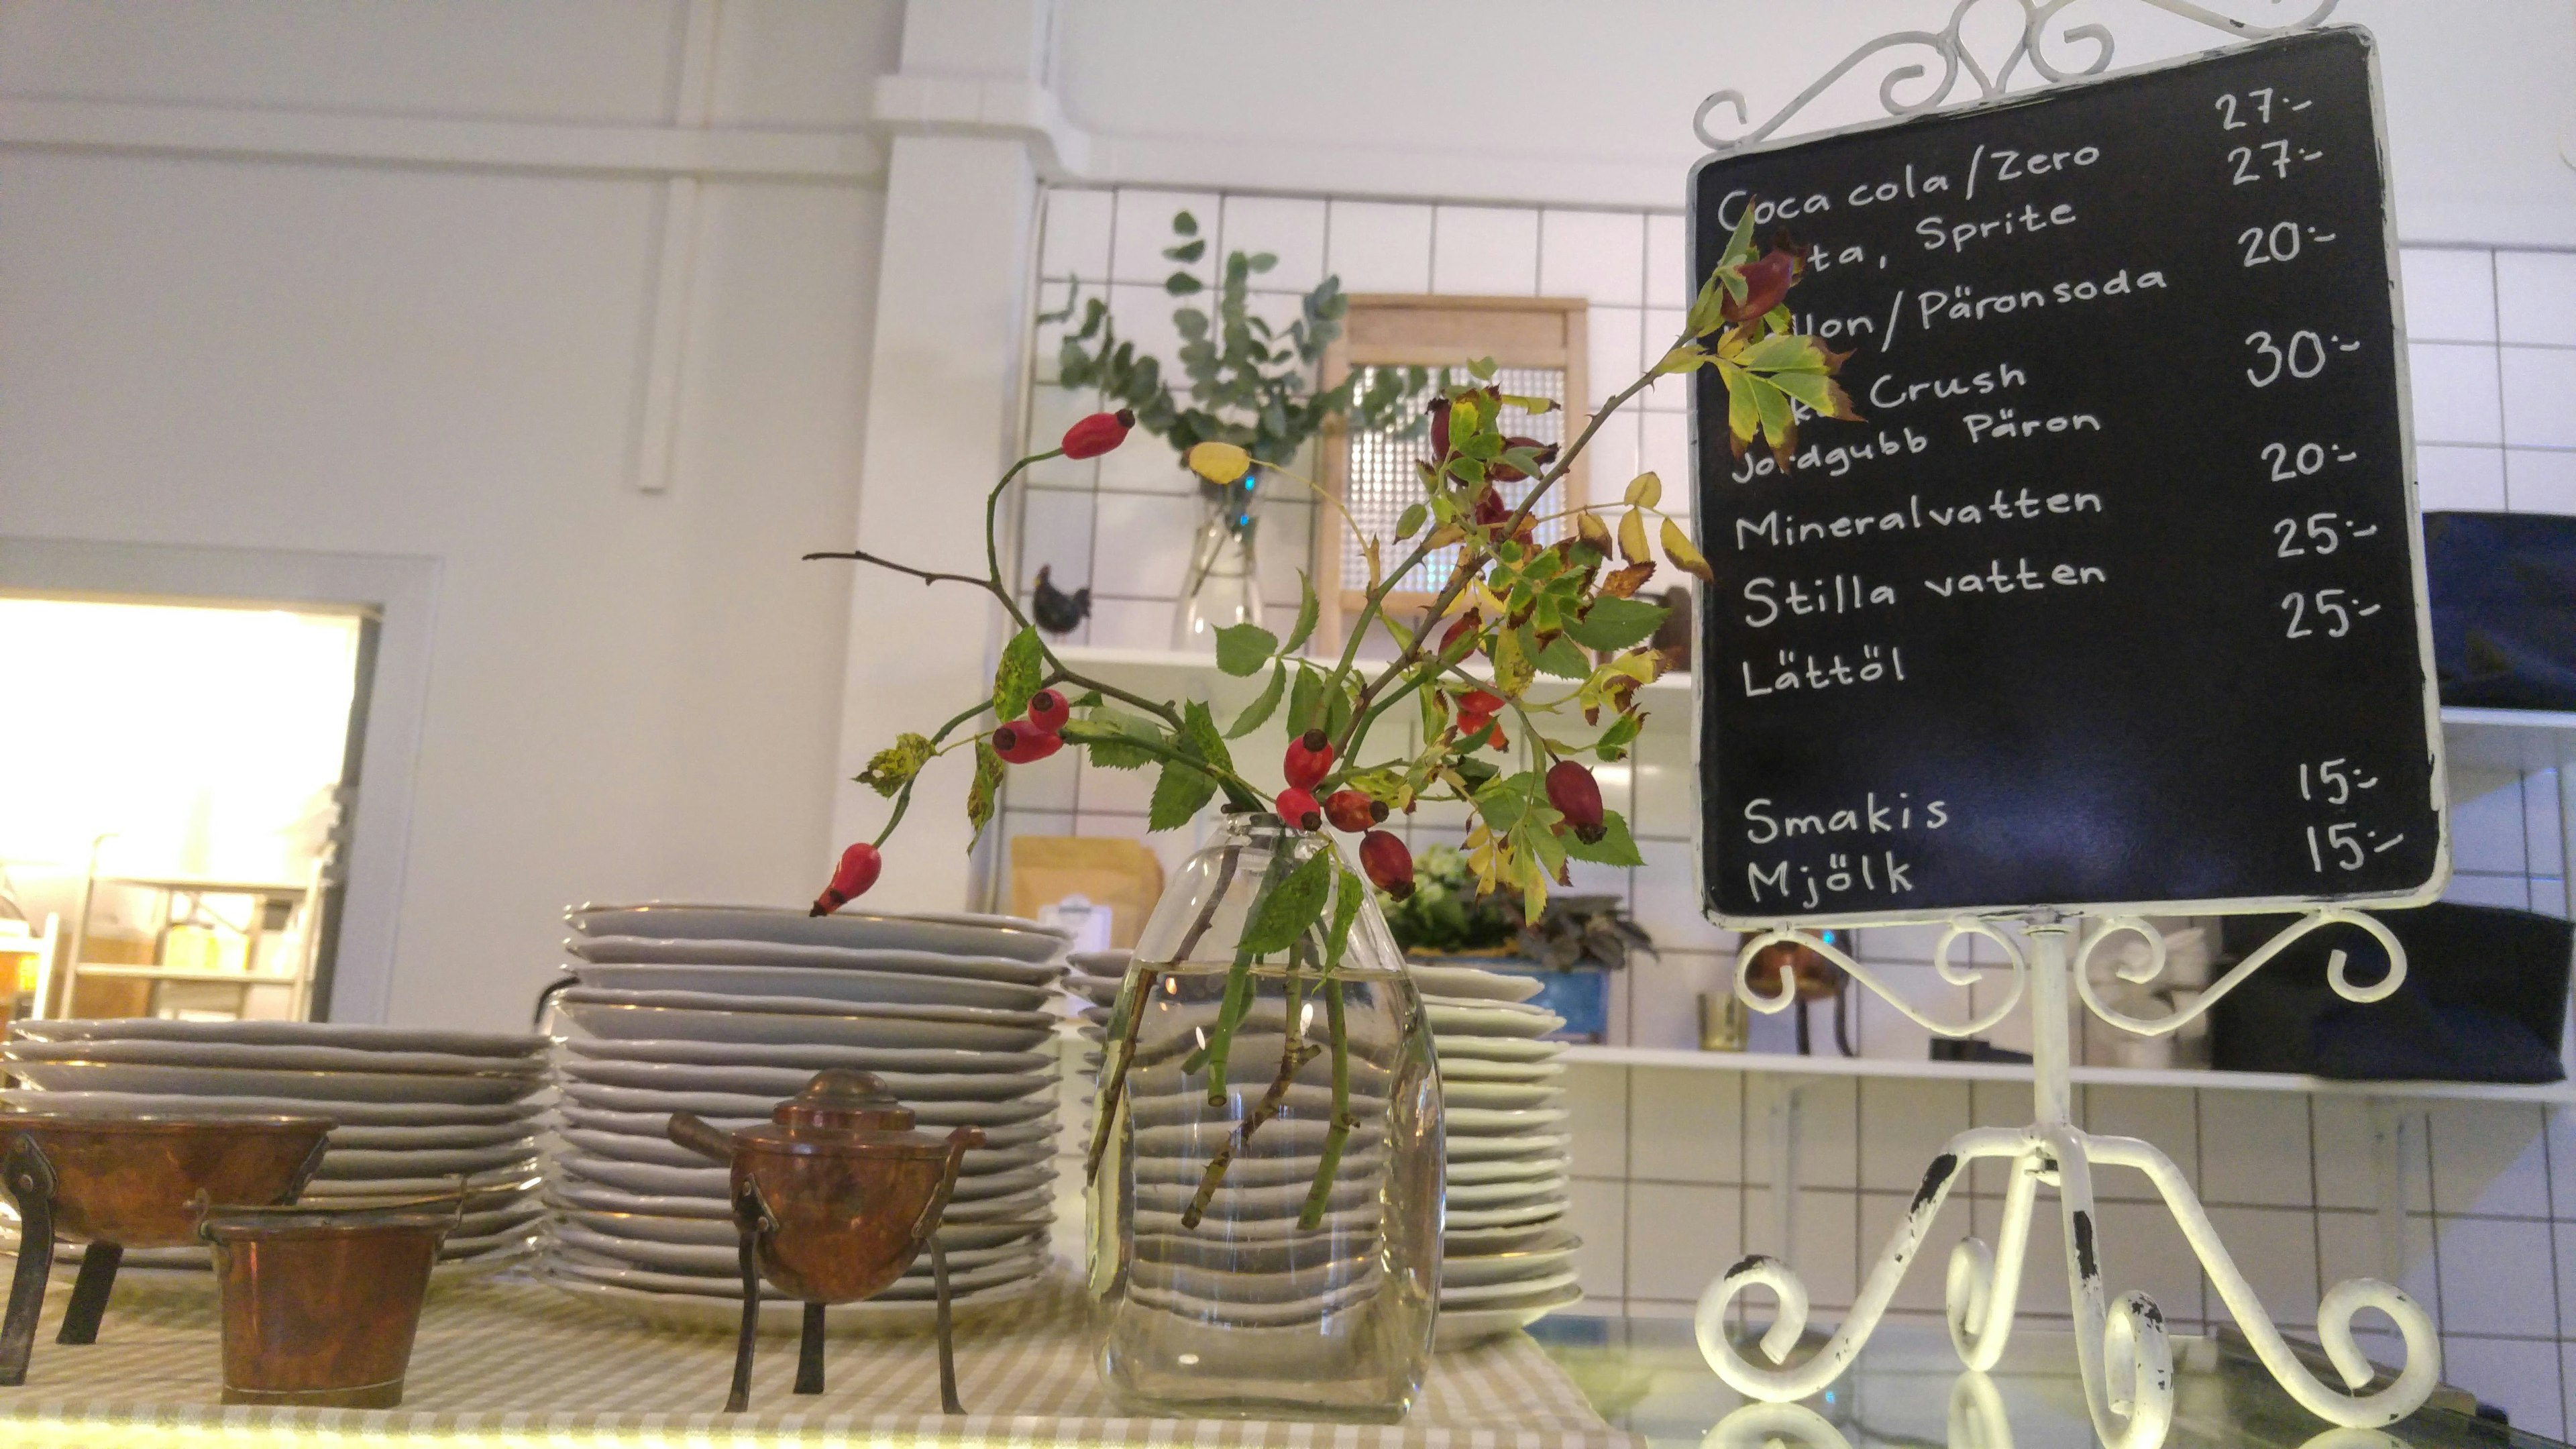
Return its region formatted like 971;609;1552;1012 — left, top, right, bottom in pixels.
1005;191;2576;1436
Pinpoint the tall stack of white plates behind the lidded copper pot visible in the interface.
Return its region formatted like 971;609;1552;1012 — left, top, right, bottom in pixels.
539;905;1064;1328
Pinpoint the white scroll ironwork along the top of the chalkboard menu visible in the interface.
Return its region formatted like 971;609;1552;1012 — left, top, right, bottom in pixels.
1690;0;2337;152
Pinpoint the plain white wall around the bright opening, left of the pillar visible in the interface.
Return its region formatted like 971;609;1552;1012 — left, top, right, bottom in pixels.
0;0;899;1026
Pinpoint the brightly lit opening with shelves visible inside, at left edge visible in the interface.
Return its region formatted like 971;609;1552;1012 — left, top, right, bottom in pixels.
0;590;378;1021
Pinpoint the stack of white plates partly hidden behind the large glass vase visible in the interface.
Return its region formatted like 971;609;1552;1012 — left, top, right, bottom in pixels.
1064;951;1585;1348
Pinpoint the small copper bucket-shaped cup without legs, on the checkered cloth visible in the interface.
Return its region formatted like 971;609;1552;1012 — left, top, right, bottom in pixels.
199;1199;461;1408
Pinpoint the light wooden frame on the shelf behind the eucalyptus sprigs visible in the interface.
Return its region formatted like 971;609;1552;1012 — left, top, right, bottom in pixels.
1313;291;1592;647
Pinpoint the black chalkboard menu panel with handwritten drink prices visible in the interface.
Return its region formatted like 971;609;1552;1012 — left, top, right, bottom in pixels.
1690;28;2450;926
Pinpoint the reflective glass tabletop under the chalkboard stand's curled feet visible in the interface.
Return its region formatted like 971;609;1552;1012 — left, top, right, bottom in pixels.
1530;1315;2555;1449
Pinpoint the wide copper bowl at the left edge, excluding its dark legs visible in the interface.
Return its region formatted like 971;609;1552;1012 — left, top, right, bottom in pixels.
0;1112;335;1248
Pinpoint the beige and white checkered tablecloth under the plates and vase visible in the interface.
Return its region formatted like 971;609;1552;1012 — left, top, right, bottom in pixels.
0;1279;1641;1449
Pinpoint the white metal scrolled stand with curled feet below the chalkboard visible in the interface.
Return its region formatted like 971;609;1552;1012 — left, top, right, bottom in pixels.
1695;908;2442;1449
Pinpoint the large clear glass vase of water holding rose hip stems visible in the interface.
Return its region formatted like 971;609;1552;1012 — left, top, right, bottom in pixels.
1089;812;1442;1424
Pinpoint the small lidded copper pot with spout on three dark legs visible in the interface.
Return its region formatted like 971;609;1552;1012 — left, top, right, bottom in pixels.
667;1070;984;1413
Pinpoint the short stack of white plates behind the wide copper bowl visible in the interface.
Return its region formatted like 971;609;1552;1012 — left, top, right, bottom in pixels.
0;1016;546;1274
